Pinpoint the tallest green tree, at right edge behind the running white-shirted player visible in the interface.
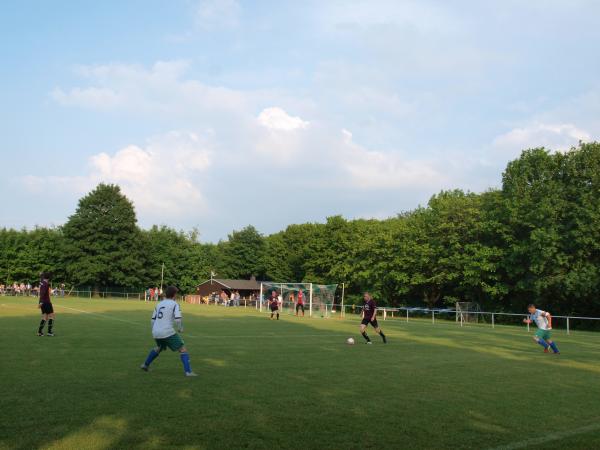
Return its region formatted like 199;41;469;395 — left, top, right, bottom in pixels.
503;143;600;313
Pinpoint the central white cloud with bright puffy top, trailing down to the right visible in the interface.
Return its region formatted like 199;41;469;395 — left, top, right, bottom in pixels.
255;107;448;190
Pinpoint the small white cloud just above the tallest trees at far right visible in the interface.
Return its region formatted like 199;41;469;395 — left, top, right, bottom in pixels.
493;122;591;155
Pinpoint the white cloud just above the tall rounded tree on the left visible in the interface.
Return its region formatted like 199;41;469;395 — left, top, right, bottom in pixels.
23;131;212;223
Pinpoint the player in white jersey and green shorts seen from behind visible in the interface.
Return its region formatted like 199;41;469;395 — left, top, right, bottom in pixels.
141;286;197;377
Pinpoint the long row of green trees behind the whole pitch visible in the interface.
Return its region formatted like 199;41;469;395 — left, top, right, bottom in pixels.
0;143;600;315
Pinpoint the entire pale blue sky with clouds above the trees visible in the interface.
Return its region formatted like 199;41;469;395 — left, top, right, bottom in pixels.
0;0;600;241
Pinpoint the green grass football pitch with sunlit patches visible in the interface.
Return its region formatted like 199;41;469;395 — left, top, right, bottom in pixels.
0;297;600;449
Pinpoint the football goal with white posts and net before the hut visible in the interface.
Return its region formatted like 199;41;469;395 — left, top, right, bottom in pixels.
259;282;338;317
